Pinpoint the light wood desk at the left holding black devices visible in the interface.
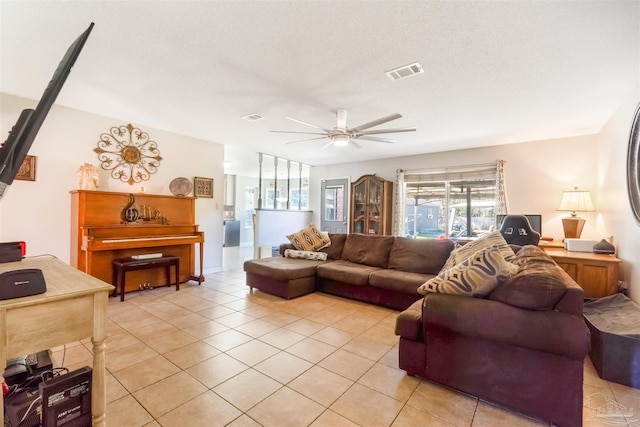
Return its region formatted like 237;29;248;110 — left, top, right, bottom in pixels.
0;256;113;427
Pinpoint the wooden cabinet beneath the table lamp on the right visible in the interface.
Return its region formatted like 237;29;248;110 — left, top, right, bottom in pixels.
545;248;622;298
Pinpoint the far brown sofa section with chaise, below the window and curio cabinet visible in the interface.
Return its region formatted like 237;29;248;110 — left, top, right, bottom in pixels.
244;233;454;310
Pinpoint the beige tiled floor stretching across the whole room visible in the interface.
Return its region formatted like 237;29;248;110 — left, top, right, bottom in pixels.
54;248;640;427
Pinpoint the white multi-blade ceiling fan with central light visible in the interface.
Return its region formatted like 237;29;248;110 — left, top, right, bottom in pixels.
271;108;416;148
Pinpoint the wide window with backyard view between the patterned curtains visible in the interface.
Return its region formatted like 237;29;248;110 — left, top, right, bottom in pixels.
404;165;496;240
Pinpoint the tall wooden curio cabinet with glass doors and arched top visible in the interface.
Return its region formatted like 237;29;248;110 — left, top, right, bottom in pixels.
350;175;393;235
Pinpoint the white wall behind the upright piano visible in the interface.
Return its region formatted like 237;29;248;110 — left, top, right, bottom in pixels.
0;93;224;273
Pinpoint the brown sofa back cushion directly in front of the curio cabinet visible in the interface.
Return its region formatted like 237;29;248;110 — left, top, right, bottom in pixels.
342;233;394;268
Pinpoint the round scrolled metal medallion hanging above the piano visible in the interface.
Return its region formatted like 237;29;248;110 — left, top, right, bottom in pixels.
93;124;162;185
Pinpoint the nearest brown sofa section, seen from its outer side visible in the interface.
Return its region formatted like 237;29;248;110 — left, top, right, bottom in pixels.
396;246;591;426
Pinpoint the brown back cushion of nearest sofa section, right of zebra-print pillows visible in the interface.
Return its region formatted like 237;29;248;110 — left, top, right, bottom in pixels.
489;245;568;310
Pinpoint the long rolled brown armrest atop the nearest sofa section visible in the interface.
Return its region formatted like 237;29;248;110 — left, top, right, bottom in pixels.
422;294;591;360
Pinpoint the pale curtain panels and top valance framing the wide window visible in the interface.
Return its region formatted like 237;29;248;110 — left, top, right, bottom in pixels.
393;160;509;236
